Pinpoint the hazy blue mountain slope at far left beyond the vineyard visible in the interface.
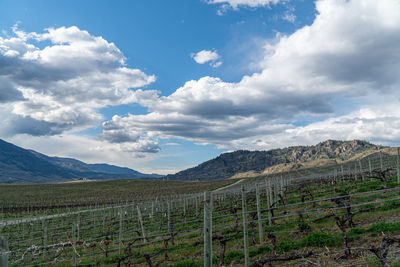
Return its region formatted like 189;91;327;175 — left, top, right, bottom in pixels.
0;139;162;183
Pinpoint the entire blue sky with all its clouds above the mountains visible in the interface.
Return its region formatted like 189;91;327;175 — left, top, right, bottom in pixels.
0;0;400;174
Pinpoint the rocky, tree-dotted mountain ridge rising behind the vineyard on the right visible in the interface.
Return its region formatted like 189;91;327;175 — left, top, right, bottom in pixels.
166;140;383;180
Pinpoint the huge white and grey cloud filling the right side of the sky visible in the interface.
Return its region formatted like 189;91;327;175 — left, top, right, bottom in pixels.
103;0;400;149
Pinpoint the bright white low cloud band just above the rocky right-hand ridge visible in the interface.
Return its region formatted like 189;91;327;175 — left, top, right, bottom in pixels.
247;101;400;151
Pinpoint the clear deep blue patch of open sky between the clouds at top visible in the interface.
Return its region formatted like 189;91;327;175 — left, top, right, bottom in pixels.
0;0;315;95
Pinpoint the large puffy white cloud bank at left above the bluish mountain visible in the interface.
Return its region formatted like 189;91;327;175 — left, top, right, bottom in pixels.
0;26;156;140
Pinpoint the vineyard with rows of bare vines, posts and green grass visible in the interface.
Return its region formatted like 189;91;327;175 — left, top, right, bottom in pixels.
0;153;400;267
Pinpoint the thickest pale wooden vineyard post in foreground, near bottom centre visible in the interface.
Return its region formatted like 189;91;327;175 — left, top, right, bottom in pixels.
203;192;212;267
